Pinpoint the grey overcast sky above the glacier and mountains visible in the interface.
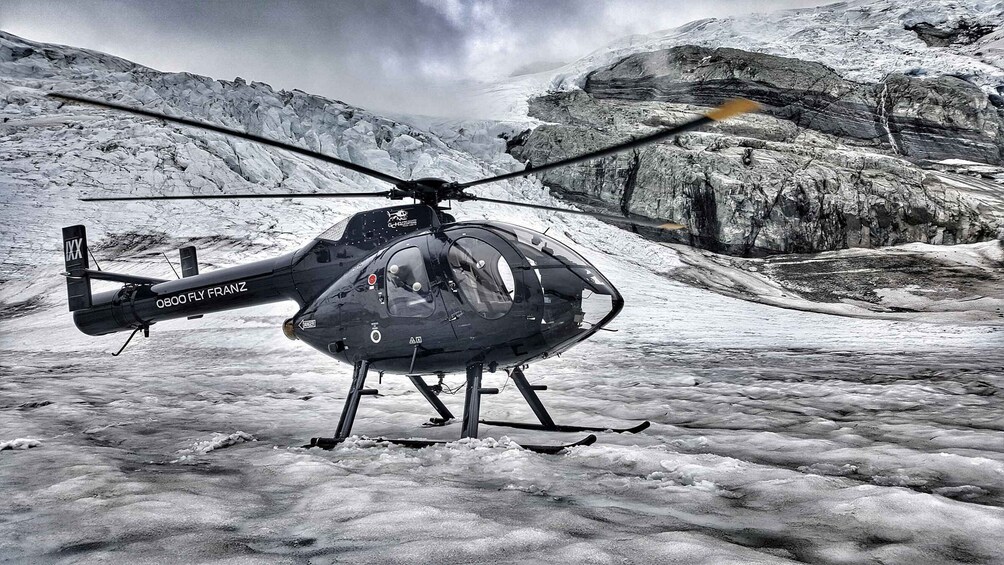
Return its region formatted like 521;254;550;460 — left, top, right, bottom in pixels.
0;0;826;113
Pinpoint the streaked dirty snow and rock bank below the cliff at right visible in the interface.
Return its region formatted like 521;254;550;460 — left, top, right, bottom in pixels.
670;241;1004;326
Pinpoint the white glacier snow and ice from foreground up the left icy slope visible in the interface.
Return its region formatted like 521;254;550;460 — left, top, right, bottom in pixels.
0;7;1004;564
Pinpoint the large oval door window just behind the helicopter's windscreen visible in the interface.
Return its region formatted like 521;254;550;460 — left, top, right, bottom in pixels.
449;237;515;320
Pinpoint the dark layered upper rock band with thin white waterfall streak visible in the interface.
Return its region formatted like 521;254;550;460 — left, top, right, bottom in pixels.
583;45;1004;164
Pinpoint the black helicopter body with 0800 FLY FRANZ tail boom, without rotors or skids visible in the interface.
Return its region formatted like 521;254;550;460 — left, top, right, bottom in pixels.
67;205;623;374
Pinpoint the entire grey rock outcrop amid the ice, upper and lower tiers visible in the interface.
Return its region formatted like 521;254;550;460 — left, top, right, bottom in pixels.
511;46;1004;255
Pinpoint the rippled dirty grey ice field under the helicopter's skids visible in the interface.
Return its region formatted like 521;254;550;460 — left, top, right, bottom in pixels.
0;249;1004;564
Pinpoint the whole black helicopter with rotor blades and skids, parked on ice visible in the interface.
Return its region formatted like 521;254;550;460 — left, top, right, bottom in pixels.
49;93;758;453
